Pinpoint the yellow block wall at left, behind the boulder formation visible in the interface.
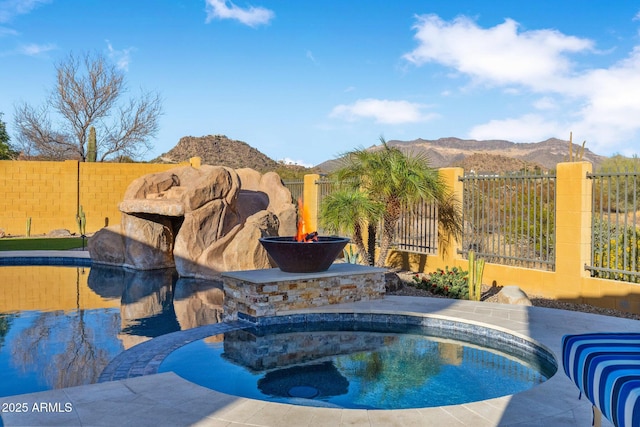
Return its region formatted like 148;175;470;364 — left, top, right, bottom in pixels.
0;158;200;235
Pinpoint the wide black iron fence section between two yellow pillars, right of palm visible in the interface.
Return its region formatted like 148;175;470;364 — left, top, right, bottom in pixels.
459;172;556;270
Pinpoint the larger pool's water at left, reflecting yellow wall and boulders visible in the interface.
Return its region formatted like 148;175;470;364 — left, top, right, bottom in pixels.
0;266;223;397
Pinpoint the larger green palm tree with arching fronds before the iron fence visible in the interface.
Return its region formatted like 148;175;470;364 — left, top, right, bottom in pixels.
321;138;462;267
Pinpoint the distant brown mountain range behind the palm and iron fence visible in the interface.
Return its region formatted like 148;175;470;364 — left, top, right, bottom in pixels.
317;138;604;172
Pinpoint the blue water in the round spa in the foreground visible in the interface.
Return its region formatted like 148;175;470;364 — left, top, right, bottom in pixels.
159;323;557;409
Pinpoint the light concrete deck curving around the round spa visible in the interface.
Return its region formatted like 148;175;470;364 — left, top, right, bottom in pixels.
0;296;640;427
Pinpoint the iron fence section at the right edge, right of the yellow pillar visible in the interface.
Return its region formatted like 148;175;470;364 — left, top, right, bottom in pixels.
585;171;640;283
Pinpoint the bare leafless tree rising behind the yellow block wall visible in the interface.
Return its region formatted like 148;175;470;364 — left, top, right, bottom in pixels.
15;53;162;161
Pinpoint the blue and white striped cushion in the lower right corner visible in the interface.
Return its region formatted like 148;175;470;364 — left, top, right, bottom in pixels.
562;333;640;427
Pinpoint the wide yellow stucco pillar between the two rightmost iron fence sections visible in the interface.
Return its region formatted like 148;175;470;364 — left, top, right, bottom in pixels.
555;162;592;296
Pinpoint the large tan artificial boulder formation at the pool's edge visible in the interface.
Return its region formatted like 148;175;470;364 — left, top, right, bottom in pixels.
88;165;296;278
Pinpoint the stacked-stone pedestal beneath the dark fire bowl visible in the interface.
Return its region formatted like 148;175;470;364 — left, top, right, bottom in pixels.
222;263;386;320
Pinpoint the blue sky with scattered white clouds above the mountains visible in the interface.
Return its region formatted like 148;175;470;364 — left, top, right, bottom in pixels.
0;0;640;165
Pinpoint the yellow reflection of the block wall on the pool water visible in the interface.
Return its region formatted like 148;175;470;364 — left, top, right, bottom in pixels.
0;266;120;313
